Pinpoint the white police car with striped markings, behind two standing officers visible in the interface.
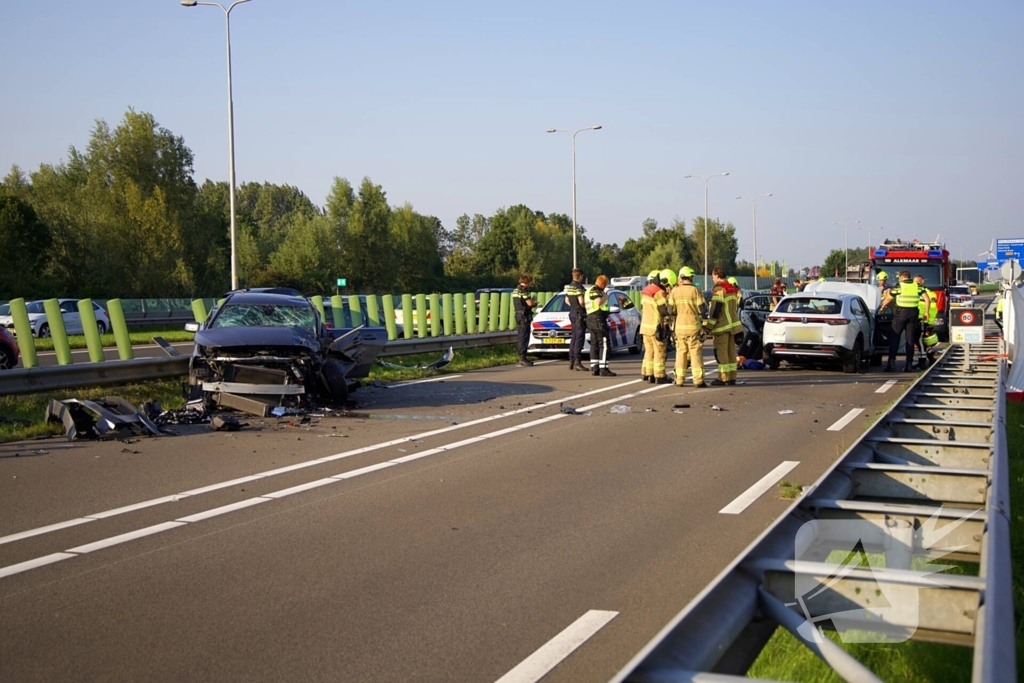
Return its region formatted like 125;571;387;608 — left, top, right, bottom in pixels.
529;286;643;354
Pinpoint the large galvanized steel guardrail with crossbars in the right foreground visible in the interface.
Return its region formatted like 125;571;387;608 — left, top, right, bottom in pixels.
612;325;1019;683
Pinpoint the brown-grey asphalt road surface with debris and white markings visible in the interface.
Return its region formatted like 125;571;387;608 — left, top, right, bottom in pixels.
0;355;913;683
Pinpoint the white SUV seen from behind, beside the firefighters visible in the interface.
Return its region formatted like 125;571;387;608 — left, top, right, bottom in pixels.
762;283;881;373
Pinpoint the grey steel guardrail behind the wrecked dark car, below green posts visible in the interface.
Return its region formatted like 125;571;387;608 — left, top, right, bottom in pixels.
0;332;515;396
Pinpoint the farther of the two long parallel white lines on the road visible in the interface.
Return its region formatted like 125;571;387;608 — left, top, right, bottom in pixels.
0;380;640;545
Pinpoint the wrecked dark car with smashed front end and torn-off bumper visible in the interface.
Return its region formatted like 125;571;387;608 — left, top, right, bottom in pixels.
185;291;387;416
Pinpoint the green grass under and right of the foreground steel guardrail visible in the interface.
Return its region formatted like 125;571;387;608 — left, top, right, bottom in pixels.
746;403;1024;683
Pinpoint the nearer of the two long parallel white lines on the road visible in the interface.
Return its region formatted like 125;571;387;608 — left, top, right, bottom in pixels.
0;382;671;577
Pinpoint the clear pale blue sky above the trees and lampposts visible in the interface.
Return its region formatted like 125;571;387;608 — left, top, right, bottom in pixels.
0;0;1024;265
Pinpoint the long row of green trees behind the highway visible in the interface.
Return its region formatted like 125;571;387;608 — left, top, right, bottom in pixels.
0;109;753;300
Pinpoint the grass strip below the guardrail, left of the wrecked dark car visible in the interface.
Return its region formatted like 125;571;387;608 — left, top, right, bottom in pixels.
0;380;185;443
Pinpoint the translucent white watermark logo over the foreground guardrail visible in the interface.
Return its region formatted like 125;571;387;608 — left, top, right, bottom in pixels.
786;508;979;643
